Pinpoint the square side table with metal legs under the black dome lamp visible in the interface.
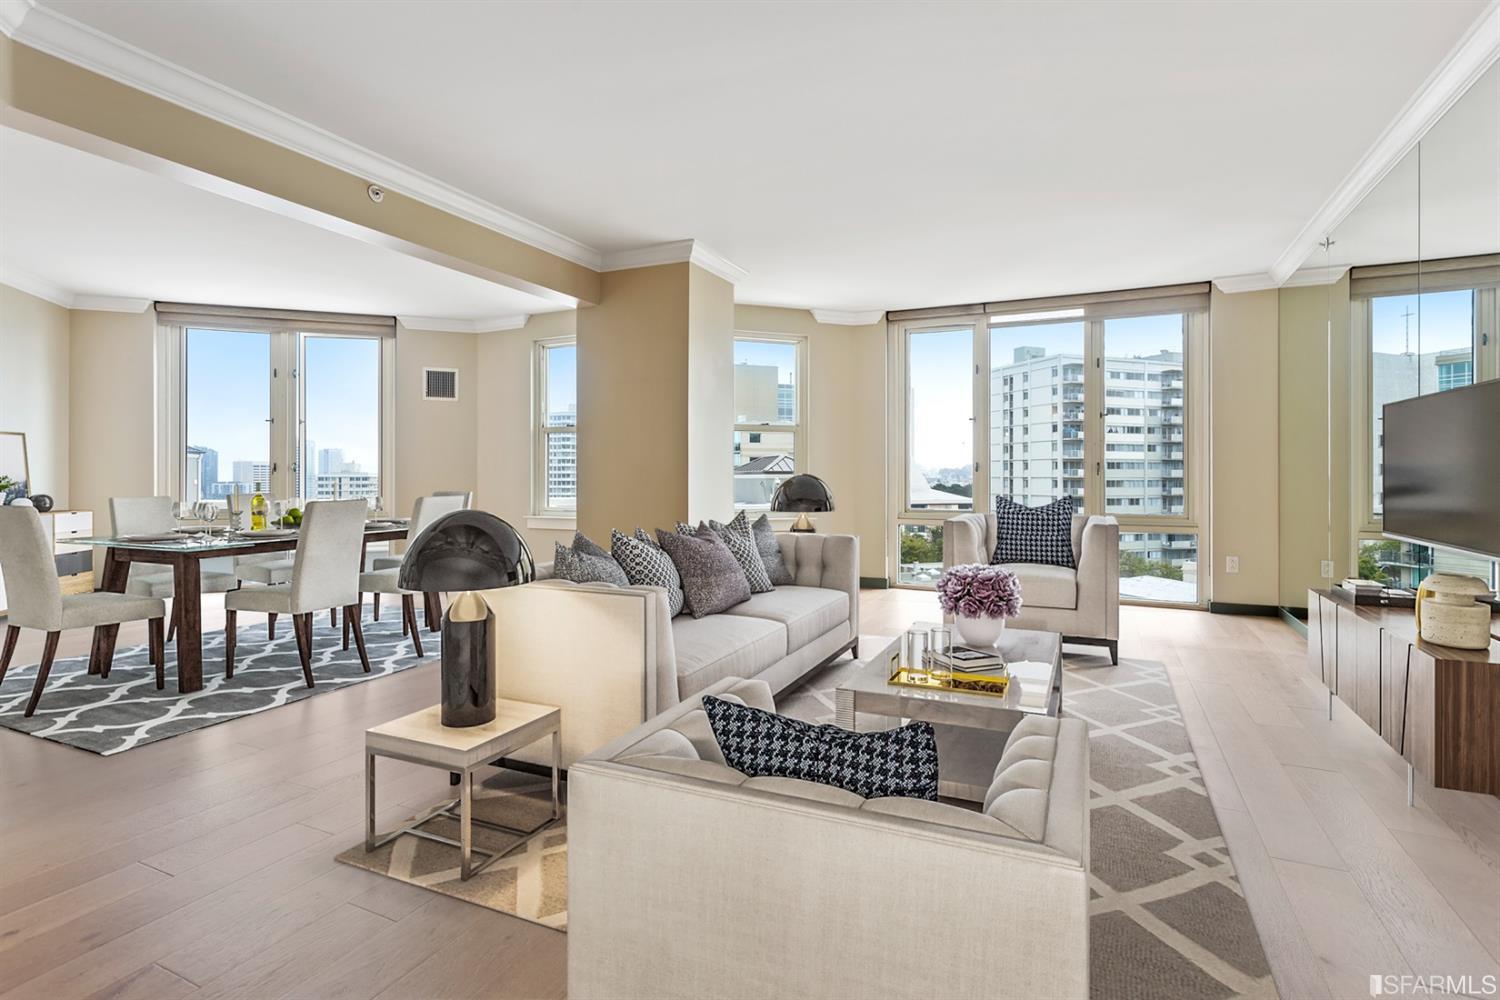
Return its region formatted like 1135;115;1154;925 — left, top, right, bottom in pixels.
365;699;563;882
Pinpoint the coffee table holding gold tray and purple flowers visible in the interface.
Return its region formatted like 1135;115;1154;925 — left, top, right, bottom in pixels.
834;622;1062;802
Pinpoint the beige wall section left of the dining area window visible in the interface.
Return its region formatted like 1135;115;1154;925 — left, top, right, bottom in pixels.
68;309;156;531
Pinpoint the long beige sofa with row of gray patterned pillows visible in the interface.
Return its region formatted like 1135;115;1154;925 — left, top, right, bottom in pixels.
485;534;860;766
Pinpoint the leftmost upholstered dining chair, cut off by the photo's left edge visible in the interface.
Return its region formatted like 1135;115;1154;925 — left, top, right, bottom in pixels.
0;507;167;718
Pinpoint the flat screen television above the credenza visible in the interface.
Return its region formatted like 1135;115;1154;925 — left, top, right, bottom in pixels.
1385;381;1500;558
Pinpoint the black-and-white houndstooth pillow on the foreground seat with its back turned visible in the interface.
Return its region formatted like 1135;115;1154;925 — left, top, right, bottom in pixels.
704;696;938;799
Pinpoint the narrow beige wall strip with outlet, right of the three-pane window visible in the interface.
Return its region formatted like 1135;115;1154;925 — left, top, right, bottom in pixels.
1208;288;1281;606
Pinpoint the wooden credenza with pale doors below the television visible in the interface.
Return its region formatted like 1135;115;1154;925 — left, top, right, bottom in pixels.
1308;591;1500;796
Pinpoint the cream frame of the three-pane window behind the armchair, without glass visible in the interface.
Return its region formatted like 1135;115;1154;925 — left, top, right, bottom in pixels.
887;307;1214;607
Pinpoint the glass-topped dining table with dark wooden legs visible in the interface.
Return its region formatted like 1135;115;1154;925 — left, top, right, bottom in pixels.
72;520;411;694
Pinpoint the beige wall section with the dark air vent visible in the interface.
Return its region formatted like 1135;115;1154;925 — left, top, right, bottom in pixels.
387;324;486;514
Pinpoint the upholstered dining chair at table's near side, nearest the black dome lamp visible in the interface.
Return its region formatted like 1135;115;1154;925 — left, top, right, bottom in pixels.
224;499;371;688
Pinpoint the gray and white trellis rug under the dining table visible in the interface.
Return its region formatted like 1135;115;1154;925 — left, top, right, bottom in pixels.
0;615;441;756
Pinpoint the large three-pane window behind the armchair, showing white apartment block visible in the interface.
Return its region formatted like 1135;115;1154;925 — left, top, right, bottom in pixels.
893;286;1208;604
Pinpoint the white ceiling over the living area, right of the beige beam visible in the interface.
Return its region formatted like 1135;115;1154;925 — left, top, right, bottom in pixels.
11;0;1485;309
